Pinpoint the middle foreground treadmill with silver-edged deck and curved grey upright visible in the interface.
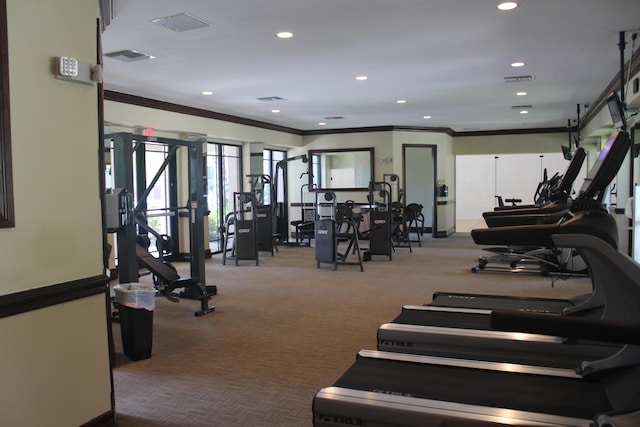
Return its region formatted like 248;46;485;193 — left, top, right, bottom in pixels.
378;231;640;373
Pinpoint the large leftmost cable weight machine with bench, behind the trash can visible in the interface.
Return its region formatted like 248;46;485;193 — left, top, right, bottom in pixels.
105;132;217;316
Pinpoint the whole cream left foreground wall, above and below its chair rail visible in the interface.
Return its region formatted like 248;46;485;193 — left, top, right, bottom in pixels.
0;0;111;426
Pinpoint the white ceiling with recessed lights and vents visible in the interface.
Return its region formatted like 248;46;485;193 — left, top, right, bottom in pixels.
102;0;640;132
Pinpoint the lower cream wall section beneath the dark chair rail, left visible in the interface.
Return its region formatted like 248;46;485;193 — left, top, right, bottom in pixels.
0;295;111;427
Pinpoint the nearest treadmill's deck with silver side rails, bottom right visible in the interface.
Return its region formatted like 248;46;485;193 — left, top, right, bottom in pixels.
313;344;640;427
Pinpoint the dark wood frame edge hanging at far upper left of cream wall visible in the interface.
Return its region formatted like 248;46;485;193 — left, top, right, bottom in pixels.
0;0;16;228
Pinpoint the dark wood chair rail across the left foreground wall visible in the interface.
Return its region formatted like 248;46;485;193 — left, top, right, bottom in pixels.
0;275;109;319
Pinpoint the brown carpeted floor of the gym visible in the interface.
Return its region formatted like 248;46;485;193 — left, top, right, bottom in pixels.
113;233;590;427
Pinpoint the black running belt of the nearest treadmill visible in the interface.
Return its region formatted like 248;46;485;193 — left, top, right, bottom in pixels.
334;358;612;419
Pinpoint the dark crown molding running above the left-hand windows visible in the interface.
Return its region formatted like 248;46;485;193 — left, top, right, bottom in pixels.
104;90;302;135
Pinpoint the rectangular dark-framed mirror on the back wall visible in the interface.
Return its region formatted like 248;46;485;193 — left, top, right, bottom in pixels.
309;148;375;191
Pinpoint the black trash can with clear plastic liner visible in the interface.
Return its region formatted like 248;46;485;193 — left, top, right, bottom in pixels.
115;284;155;360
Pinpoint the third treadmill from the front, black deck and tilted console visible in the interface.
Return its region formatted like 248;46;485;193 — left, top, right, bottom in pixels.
430;131;631;314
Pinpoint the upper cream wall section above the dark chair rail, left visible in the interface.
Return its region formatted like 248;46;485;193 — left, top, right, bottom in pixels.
0;0;102;294
